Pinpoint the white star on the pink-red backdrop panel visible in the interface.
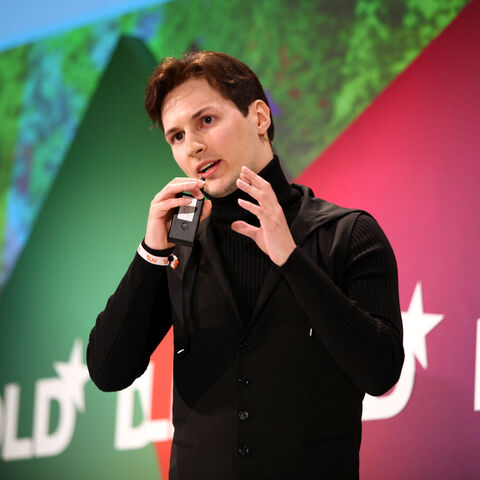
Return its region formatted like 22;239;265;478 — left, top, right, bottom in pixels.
402;282;444;369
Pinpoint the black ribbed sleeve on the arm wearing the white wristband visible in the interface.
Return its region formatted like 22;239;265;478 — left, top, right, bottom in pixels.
87;250;171;391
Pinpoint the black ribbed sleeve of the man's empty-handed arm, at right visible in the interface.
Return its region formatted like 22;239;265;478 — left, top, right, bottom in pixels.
280;215;404;395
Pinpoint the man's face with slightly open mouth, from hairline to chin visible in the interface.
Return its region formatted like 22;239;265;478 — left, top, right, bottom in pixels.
162;78;271;197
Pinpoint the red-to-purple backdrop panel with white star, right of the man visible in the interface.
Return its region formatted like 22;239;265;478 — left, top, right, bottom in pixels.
297;0;480;480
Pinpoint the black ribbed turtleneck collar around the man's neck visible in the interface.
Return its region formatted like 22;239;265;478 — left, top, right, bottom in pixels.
205;155;300;223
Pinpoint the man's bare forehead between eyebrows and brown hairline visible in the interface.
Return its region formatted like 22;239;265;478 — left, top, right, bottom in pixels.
162;78;236;131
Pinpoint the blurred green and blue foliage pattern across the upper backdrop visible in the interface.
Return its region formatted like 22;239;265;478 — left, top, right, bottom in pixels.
0;0;468;283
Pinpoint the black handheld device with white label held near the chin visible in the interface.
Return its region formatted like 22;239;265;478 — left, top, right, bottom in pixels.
168;193;203;247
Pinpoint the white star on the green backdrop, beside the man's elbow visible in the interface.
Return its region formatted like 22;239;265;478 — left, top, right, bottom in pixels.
53;339;89;412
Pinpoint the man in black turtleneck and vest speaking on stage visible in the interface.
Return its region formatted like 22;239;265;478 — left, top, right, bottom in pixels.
87;52;403;480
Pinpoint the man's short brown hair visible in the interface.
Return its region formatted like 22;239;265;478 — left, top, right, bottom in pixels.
145;50;274;142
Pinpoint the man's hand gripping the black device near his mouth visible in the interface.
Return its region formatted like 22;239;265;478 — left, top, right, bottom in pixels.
145;177;212;250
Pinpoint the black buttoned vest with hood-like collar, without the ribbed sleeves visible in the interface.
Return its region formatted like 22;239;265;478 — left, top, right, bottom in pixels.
168;186;364;480
